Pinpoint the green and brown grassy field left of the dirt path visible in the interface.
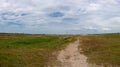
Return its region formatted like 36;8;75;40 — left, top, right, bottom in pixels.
0;33;74;67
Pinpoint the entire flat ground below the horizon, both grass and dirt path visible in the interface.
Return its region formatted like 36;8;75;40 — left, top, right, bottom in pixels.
0;33;120;67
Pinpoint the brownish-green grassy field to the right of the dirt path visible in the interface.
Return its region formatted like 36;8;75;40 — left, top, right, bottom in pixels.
80;34;120;67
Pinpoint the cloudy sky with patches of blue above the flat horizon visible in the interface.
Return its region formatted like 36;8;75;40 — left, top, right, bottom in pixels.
0;0;120;34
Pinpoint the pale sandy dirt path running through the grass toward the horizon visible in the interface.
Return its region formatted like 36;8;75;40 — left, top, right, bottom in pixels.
55;40;88;67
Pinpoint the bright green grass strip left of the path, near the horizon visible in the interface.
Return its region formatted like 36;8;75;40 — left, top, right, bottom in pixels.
0;36;70;48
